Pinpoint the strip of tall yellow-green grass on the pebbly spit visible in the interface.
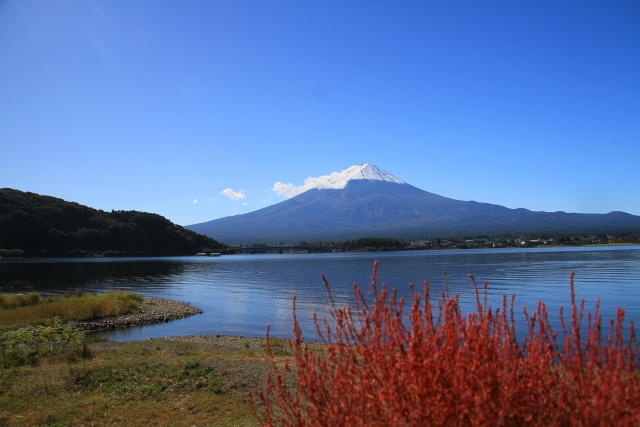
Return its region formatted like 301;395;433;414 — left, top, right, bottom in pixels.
0;292;142;327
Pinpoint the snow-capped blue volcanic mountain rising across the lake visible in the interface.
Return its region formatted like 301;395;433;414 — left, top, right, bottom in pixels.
185;164;640;244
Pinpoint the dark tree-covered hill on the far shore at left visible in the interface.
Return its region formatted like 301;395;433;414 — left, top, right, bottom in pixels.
0;188;227;256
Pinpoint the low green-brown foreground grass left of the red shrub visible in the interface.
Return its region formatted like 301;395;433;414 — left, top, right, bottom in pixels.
0;337;288;426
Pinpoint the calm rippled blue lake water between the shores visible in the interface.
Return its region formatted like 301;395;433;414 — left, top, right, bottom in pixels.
0;246;640;340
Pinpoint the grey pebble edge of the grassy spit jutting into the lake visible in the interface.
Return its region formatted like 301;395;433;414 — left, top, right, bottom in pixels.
68;297;202;331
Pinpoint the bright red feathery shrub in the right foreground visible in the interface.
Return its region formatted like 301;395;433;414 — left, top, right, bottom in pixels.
252;263;640;426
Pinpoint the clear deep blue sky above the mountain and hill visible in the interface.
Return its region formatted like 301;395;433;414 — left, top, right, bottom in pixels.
0;0;640;225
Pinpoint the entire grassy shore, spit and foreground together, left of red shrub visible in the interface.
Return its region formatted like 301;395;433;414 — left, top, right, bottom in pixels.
0;292;278;426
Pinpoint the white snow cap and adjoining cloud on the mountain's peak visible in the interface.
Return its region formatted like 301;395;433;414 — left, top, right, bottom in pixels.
271;163;404;197
